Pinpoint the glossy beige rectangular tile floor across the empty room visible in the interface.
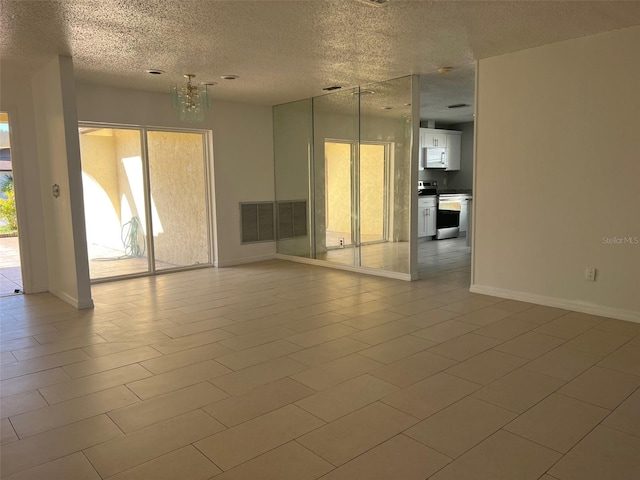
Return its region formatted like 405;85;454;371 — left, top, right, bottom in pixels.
0;256;640;480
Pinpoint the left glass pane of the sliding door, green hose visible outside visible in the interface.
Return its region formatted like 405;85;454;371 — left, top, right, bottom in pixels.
79;127;149;280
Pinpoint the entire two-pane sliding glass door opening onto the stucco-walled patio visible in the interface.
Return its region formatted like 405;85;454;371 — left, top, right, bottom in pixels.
79;124;211;280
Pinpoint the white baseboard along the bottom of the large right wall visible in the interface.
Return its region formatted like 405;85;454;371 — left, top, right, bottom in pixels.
469;285;640;323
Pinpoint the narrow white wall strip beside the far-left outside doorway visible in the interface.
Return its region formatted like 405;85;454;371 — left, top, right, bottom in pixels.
0;60;49;293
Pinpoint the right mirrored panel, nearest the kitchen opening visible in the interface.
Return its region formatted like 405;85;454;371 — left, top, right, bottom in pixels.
359;77;412;273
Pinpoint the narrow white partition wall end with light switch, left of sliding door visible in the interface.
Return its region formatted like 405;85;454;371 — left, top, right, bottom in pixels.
32;57;93;308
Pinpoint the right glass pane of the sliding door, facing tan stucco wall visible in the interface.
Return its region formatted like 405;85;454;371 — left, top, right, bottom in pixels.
147;131;210;270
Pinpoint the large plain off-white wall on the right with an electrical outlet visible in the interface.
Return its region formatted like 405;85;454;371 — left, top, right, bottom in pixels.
471;27;640;321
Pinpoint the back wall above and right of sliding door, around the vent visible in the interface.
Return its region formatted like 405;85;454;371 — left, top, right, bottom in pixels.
77;85;275;266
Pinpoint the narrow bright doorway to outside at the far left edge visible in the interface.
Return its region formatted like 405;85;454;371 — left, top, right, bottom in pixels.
0;112;22;296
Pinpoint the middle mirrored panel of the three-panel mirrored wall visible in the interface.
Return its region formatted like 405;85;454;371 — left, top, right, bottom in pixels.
312;89;360;265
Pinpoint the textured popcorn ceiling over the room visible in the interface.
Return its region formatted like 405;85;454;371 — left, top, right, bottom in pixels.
0;0;640;121
